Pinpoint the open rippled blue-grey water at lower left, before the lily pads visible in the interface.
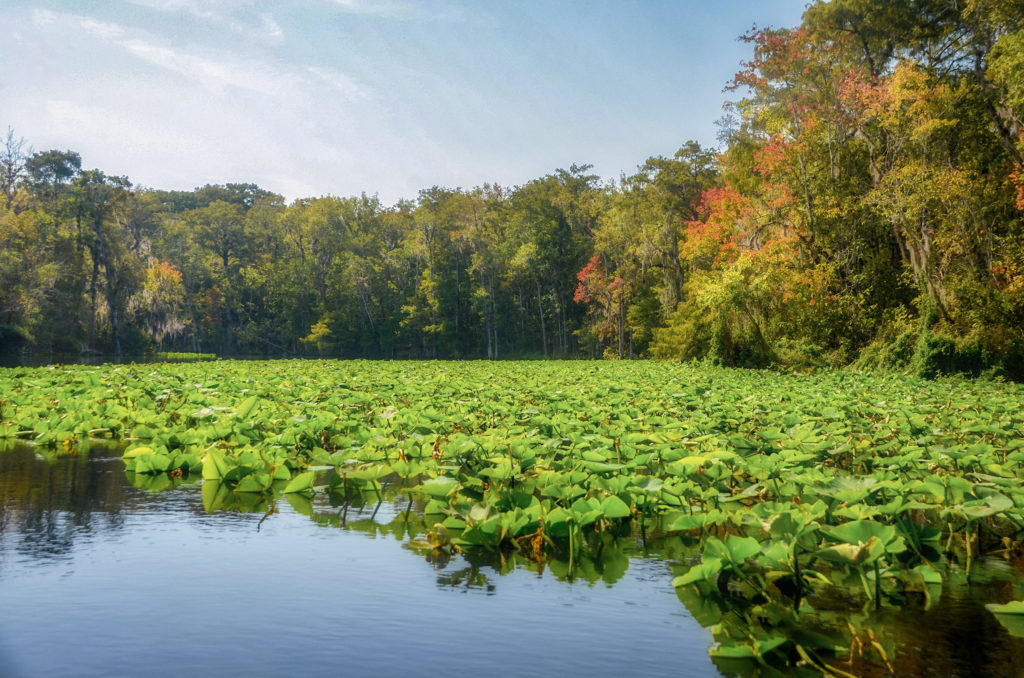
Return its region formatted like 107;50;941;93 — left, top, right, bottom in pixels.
0;449;720;678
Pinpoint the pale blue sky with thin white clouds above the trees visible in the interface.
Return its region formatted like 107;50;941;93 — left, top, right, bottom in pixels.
0;0;806;204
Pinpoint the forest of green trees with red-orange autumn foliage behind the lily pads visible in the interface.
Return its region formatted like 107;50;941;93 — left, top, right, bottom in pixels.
0;0;1024;379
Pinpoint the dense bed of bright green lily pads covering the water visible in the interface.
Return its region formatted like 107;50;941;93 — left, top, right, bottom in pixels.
0;361;1024;675
